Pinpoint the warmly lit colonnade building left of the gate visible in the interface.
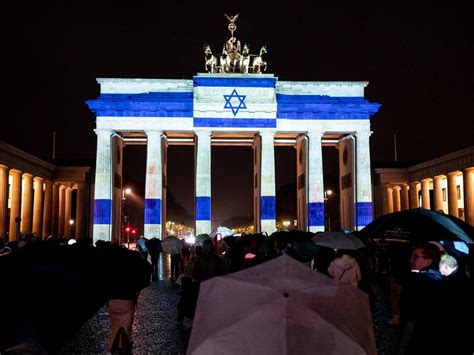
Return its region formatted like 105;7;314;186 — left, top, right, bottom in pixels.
0;141;91;241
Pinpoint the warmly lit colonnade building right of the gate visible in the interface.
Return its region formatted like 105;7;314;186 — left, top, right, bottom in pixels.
374;147;474;225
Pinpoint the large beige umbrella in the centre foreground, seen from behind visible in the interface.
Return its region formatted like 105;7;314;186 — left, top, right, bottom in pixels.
187;255;376;355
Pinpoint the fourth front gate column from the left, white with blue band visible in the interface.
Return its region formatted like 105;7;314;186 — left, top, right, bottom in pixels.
260;132;276;235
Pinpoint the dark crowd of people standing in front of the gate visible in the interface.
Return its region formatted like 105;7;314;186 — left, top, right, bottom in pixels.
0;231;474;354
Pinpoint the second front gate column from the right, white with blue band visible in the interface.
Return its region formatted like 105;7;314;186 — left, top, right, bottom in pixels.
307;131;325;233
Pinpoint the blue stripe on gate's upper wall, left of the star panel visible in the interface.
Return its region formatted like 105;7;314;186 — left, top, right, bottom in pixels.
86;92;194;117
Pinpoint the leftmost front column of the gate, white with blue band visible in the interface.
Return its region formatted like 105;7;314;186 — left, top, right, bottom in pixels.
93;129;112;244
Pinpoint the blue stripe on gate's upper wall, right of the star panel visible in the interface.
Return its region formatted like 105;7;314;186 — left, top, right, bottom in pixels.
276;94;381;120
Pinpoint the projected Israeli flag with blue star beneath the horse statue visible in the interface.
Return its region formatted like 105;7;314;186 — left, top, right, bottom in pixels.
193;74;277;129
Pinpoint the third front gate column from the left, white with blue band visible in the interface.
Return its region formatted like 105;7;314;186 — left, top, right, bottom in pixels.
195;131;211;235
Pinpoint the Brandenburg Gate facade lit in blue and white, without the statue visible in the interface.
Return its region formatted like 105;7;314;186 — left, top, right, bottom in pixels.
88;73;380;240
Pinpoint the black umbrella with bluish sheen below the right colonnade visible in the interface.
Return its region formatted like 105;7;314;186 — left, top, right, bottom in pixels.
357;208;474;248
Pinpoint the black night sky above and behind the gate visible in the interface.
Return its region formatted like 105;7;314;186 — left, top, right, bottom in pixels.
0;1;474;224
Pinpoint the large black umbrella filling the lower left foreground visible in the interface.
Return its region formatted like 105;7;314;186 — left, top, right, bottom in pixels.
0;243;150;353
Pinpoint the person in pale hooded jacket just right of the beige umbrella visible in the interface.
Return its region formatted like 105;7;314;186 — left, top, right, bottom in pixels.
328;250;362;286
